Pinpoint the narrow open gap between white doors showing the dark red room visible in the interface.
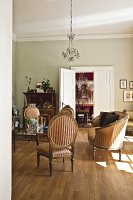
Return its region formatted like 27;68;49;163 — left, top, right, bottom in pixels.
75;72;94;126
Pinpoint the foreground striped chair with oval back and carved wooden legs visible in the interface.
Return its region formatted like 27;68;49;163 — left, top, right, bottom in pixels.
36;113;78;176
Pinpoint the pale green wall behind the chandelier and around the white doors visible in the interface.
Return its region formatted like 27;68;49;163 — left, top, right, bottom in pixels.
15;39;133;123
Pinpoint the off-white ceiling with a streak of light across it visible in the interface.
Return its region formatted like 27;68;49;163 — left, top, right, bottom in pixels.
13;0;133;40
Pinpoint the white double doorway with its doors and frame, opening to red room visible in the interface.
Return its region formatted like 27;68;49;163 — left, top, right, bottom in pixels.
59;66;114;122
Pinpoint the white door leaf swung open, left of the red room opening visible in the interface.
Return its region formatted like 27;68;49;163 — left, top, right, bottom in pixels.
59;68;75;112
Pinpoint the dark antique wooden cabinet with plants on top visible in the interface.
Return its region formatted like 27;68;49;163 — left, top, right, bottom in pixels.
23;92;56;125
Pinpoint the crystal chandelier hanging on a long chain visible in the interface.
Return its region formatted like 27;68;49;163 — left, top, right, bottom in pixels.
62;0;80;62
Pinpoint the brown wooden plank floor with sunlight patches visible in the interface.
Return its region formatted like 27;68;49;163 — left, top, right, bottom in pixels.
12;129;133;200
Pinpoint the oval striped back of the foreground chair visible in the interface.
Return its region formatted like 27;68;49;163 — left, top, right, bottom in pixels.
48;114;78;148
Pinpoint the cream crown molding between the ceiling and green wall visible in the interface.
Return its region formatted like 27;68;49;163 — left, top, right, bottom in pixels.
13;33;133;42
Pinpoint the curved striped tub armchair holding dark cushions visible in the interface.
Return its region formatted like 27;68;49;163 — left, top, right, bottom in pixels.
88;111;128;161
